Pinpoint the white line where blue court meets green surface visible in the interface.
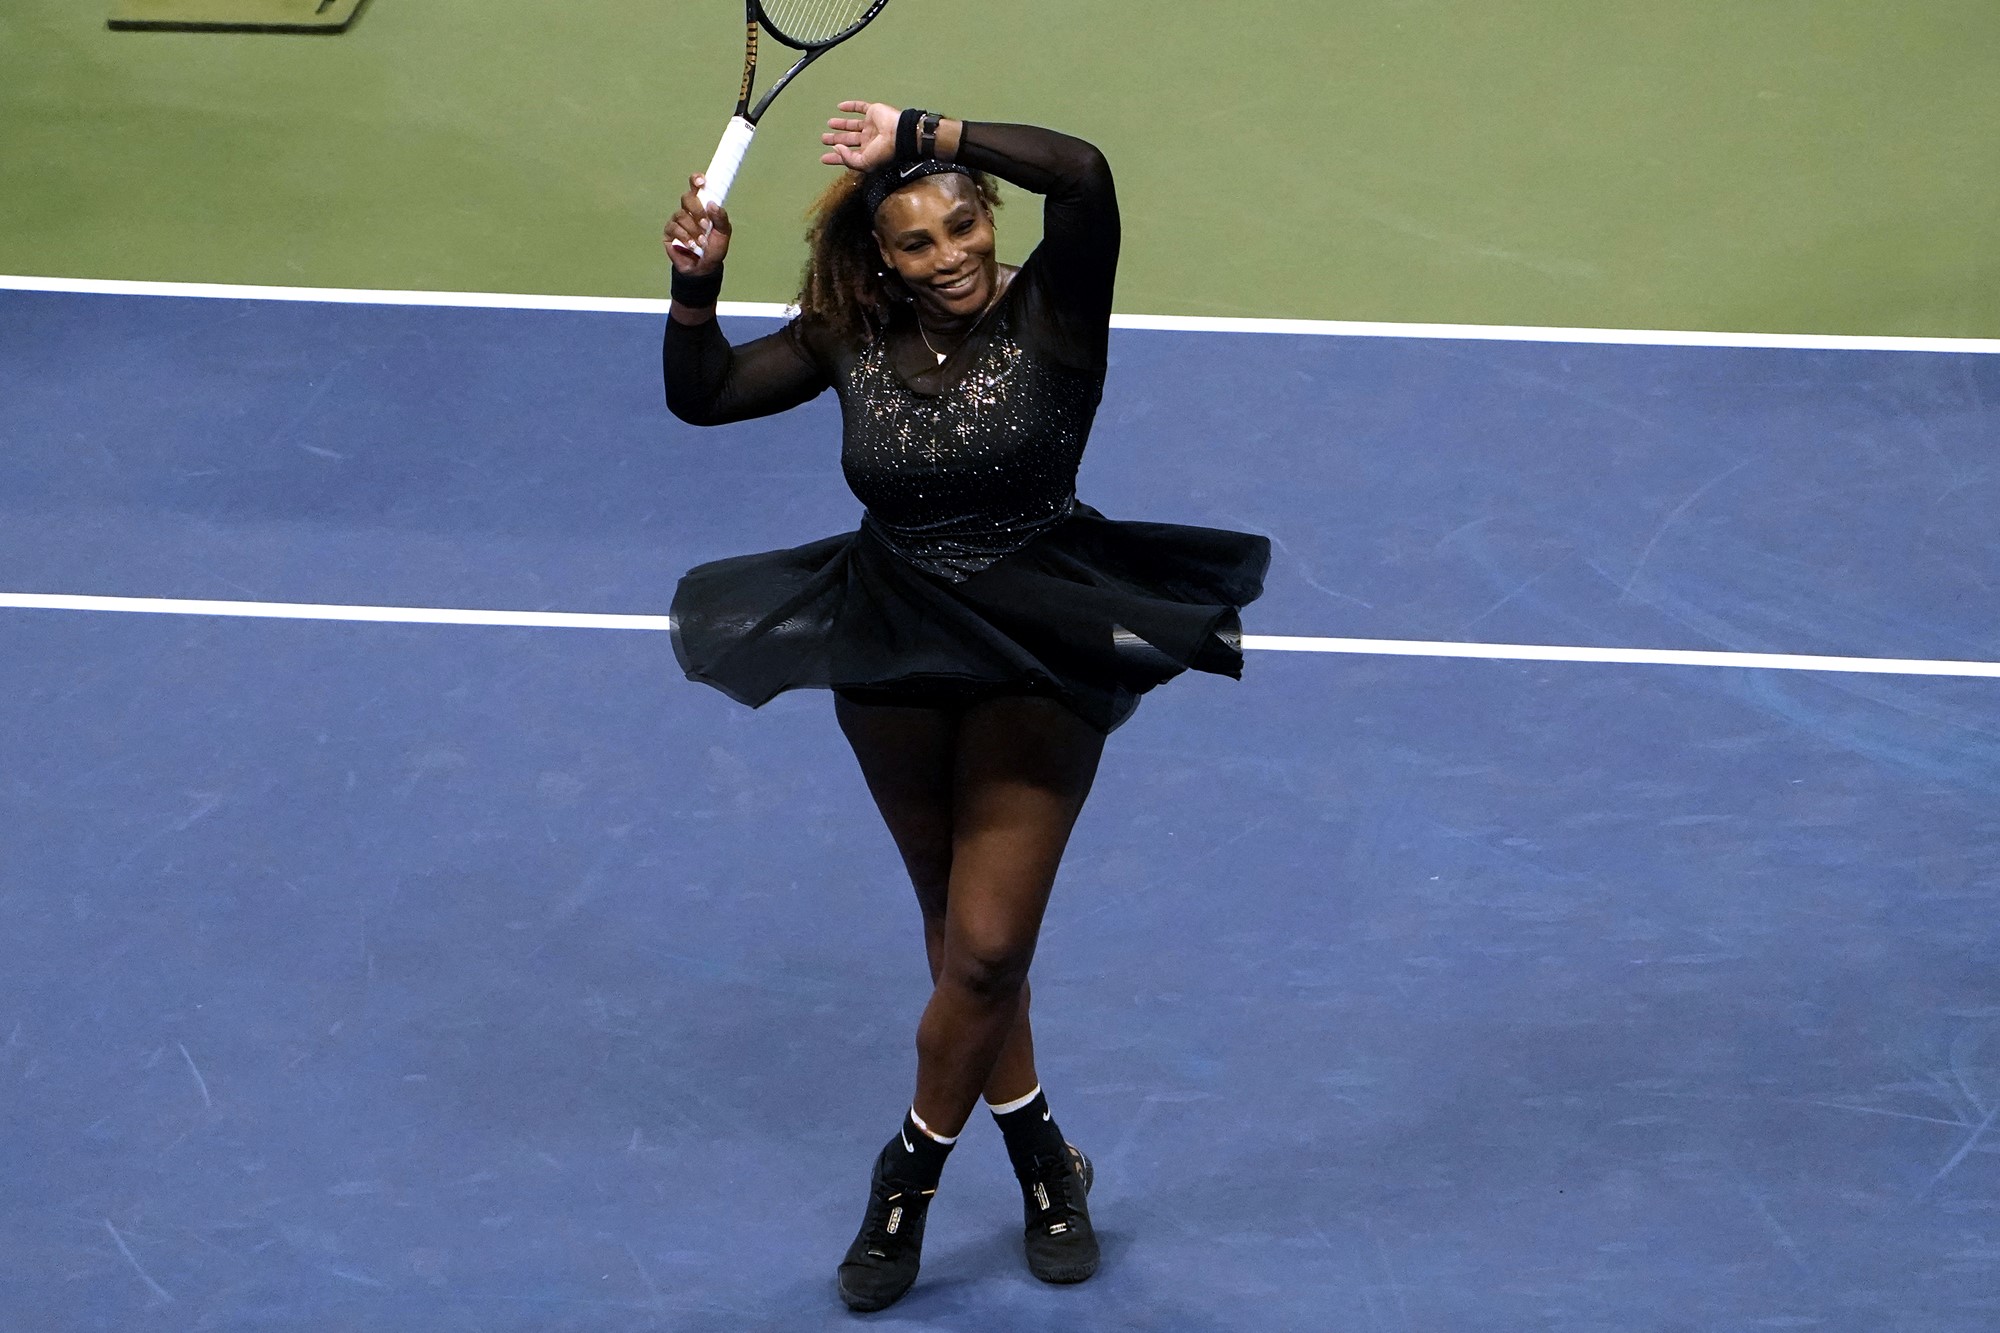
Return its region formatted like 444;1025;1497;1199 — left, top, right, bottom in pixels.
11;274;2000;354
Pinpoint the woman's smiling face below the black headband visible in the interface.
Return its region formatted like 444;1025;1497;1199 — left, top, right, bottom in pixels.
876;172;1000;324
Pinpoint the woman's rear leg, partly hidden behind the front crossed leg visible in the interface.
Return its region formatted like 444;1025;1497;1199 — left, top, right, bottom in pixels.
834;697;1040;1096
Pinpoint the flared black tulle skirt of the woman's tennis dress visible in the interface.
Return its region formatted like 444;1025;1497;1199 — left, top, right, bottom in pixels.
672;504;1270;731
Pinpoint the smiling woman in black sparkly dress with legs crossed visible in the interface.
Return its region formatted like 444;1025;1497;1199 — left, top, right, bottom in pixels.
664;102;1270;1311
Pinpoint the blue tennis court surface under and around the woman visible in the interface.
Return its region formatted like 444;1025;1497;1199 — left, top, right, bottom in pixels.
0;290;2000;1333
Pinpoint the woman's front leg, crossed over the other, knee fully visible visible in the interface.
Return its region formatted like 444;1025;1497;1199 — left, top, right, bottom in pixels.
916;697;1104;1135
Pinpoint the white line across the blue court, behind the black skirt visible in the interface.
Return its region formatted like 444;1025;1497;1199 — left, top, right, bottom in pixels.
0;592;2000;679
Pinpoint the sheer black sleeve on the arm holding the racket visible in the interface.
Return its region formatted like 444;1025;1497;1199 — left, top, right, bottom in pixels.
660;318;830;426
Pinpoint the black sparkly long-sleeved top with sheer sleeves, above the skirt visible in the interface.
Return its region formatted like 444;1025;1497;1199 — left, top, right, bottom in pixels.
662;122;1118;580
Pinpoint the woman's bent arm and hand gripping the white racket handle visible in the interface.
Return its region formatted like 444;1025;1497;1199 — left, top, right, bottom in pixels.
660;176;828;426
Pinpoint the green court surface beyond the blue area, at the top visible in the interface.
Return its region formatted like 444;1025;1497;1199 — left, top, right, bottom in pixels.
0;0;2000;336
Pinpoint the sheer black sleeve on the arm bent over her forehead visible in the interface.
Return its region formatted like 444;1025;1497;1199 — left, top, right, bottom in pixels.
956;120;1118;366
